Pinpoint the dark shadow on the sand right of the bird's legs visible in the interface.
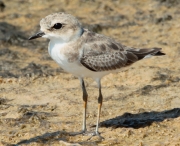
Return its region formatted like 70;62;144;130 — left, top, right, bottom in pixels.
100;108;180;129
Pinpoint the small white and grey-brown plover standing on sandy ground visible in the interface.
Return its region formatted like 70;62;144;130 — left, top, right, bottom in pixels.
29;12;165;136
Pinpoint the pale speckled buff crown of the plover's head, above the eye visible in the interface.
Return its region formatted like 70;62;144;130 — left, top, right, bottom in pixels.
40;12;80;28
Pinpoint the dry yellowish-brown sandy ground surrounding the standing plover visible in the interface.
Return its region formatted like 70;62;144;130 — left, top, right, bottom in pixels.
0;0;180;146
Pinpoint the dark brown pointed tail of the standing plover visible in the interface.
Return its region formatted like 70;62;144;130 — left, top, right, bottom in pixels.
126;48;165;60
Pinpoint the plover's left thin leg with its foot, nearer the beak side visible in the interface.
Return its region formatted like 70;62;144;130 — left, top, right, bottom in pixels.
70;78;88;136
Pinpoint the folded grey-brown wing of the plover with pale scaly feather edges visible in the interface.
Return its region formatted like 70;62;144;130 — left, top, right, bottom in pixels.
80;31;138;71
